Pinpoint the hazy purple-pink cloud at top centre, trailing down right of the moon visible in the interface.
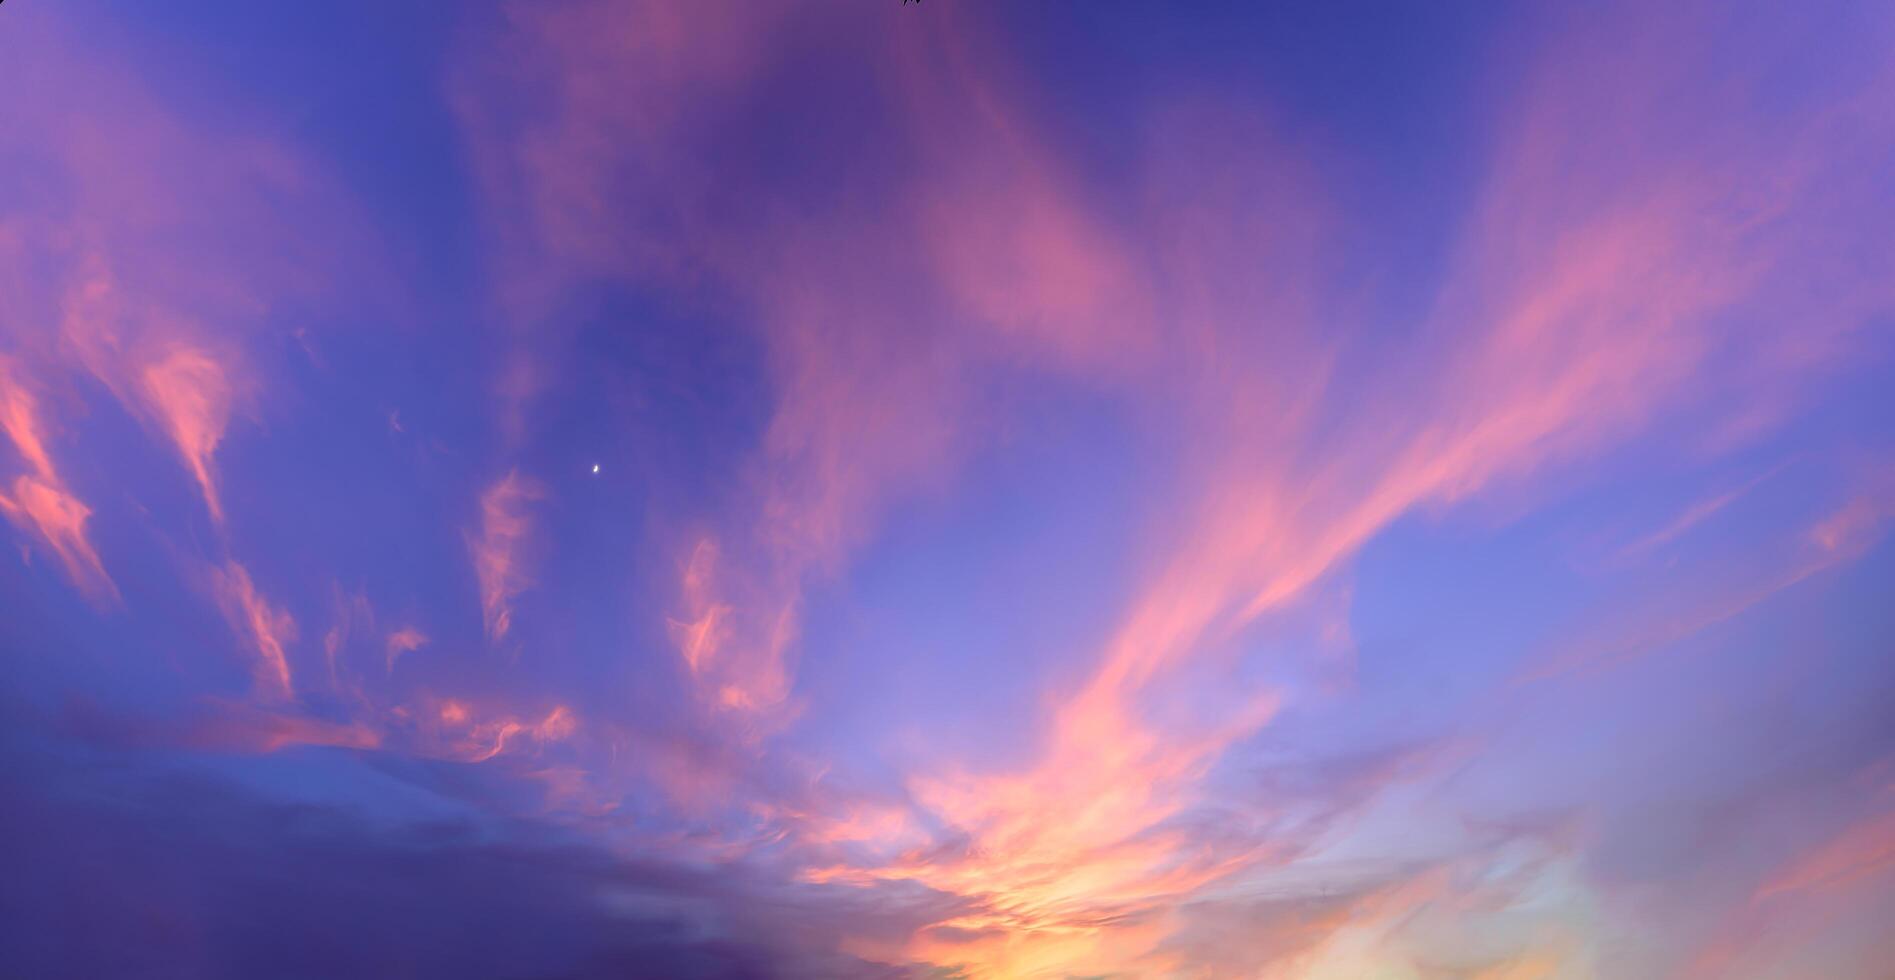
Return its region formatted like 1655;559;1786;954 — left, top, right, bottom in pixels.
453;4;1182;728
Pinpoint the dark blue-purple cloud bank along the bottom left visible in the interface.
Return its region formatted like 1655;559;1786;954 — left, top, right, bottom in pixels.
0;727;948;980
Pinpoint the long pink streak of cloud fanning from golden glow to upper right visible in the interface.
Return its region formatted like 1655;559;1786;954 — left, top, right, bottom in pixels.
780;0;1889;961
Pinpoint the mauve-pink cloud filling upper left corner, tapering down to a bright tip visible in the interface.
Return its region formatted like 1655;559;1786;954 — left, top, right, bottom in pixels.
0;3;387;542
